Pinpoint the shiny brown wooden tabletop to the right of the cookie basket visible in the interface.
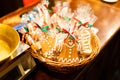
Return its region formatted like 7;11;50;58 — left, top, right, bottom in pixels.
72;0;120;48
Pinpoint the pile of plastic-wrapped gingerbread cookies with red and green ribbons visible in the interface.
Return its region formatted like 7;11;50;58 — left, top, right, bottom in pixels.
18;0;98;63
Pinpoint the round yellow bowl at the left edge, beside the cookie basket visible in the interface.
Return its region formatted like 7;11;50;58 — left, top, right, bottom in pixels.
0;24;20;62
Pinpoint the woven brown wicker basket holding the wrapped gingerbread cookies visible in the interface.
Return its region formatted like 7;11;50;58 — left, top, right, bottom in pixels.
32;33;100;73
